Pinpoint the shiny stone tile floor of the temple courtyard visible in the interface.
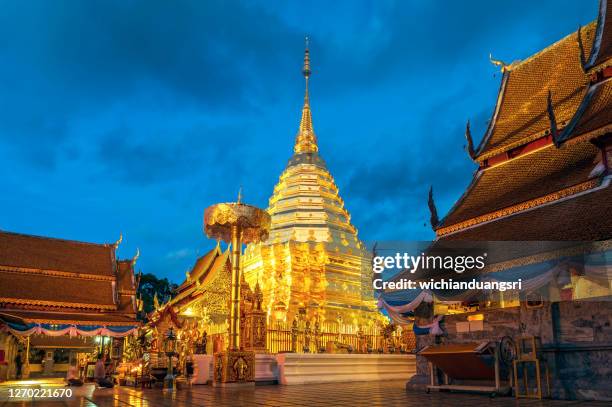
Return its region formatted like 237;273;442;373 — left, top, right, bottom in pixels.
0;381;611;407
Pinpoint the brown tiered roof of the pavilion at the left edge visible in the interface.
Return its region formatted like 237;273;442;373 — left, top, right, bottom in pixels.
0;232;136;323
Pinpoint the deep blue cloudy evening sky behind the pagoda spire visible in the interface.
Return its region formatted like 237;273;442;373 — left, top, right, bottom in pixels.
0;0;598;282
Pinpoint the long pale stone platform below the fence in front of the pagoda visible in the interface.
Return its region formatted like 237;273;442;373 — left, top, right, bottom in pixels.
276;353;416;385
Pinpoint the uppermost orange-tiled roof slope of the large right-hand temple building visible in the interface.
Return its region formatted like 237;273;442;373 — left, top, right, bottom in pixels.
476;23;595;162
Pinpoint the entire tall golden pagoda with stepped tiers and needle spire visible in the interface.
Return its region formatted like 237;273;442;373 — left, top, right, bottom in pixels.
243;39;384;326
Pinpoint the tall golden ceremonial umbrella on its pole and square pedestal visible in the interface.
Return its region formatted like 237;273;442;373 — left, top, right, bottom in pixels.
204;196;270;385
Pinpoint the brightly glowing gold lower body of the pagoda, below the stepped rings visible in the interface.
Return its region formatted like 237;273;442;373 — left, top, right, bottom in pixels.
243;241;381;325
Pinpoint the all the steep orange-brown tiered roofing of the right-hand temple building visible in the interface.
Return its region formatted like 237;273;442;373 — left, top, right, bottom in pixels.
434;4;612;240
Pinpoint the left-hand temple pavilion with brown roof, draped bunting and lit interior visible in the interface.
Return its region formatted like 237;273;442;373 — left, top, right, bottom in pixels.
0;232;140;381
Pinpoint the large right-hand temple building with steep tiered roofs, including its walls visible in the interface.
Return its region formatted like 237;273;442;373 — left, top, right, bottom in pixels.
380;0;612;400
